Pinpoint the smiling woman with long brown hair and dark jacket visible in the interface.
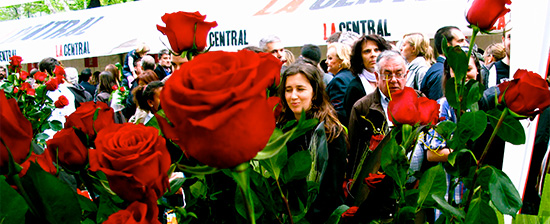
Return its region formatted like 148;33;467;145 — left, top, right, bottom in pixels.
277;61;348;223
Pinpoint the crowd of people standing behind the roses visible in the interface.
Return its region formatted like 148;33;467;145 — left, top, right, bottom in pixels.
4;23;548;223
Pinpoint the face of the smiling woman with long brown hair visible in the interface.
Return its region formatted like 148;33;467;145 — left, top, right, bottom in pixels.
285;73;313;120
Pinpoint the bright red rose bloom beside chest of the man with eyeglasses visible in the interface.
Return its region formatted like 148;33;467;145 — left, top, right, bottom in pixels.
388;87;440;125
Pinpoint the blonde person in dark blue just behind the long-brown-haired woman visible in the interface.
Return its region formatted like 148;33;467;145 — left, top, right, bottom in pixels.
326;43;354;124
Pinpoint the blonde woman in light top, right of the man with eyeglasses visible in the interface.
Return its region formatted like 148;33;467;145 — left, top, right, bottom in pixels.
400;33;434;90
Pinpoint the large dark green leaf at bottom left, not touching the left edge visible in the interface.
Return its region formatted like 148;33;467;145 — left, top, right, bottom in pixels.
21;162;82;223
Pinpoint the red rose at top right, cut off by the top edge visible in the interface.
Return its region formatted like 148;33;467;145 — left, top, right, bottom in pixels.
466;0;512;30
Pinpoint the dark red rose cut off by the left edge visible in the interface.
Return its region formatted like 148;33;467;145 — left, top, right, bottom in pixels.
0;90;33;174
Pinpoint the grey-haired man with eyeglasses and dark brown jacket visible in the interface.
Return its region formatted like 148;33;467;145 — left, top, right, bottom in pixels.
347;50;418;221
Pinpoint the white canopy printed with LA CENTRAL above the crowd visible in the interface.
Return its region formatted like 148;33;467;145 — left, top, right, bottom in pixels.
0;0;478;64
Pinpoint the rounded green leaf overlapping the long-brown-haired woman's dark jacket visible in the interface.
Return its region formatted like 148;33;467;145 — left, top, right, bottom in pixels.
281;151;311;183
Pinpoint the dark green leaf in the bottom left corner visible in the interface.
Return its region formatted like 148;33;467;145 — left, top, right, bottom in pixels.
0;176;29;224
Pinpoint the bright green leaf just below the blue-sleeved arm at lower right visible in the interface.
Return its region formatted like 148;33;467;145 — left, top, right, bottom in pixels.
418;165;447;207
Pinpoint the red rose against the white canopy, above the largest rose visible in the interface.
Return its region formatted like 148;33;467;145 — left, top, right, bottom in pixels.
157;11;218;54
